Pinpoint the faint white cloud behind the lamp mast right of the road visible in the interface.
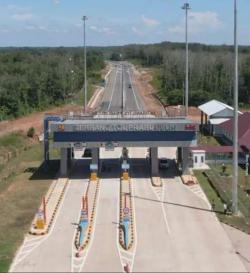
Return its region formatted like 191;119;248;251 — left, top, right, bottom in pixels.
168;11;223;34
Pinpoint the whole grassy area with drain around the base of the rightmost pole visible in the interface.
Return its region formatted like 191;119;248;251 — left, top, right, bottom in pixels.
194;164;250;233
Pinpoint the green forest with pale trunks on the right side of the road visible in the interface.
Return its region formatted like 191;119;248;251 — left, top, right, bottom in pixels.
104;42;250;107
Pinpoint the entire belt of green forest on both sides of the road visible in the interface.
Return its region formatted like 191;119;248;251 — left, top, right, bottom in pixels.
0;42;250;120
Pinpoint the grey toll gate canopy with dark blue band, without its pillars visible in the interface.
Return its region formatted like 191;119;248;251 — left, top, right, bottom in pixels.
50;116;198;148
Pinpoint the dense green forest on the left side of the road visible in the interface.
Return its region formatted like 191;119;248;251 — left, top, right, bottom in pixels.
0;48;105;120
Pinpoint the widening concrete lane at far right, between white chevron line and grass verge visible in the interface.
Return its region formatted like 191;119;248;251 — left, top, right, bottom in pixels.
164;173;245;272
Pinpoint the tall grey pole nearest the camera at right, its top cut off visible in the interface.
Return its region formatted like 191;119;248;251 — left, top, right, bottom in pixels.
232;0;239;214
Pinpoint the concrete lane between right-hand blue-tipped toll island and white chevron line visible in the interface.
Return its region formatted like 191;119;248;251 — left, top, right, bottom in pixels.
133;179;177;272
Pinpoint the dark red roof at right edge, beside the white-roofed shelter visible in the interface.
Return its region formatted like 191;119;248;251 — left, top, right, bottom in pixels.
219;112;250;150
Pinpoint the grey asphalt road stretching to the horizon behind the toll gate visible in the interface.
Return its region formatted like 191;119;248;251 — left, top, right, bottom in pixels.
100;63;145;113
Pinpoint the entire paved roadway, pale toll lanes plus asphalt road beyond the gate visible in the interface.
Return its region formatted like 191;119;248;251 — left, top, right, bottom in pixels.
10;63;246;272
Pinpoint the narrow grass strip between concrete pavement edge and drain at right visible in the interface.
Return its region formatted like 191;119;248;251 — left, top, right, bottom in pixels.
194;170;250;234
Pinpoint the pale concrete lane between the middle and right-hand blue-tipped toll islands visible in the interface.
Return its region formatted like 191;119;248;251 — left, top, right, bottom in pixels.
82;178;123;272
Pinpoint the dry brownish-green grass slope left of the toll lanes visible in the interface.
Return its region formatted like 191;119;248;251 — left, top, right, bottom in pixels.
0;137;58;272
